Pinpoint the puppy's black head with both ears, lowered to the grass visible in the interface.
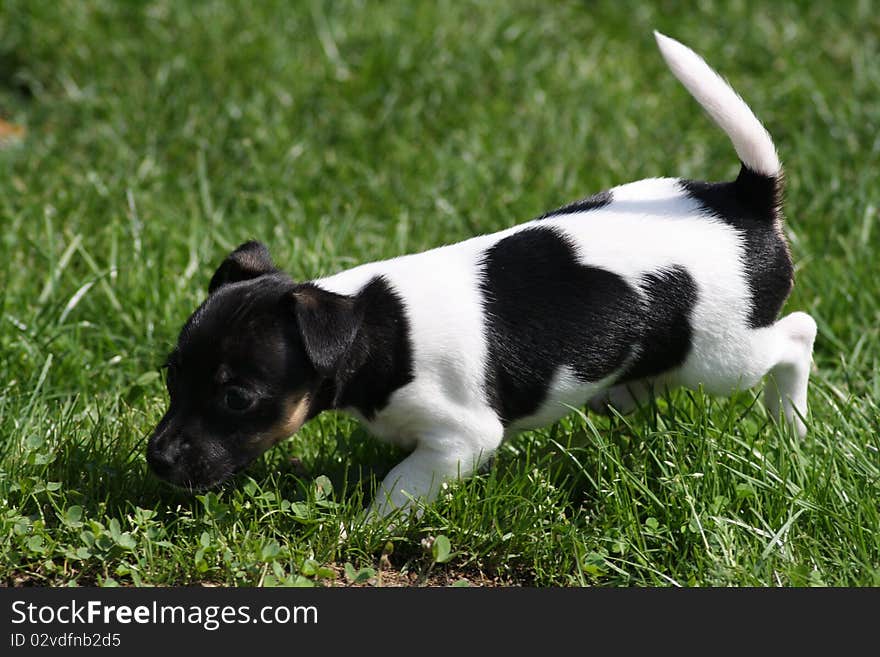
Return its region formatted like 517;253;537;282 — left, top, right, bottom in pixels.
147;242;359;489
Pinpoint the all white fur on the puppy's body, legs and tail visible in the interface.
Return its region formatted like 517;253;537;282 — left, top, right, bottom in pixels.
315;34;816;514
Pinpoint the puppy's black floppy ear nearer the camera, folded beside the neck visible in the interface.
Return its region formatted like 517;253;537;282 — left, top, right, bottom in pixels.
292;283;362;379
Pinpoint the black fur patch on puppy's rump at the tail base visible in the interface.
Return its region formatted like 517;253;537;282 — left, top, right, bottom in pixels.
679;165;794;328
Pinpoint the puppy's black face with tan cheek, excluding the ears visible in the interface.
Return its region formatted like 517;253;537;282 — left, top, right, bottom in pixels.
147;274;318;488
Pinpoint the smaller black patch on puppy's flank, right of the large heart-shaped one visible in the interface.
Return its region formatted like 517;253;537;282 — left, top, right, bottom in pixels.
619;266;697;383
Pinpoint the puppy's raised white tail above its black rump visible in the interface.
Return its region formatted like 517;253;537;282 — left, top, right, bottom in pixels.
654;32;782;177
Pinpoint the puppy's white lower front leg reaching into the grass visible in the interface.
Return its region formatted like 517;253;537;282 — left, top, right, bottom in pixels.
369;445;491;517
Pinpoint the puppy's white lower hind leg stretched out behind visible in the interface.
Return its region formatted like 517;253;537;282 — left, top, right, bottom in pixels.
764;312;816;438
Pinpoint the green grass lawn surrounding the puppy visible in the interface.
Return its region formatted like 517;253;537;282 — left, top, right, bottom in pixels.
0;0;880;586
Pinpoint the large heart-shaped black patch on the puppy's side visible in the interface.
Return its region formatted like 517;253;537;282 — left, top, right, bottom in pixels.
480;228;645;424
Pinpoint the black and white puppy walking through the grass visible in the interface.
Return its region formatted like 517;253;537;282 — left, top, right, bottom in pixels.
147;34;816;514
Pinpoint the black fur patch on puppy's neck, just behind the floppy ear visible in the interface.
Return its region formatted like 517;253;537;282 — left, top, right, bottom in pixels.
328;277;414;419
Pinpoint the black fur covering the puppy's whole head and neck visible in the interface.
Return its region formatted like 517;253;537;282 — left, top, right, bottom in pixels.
147;233;413;488
